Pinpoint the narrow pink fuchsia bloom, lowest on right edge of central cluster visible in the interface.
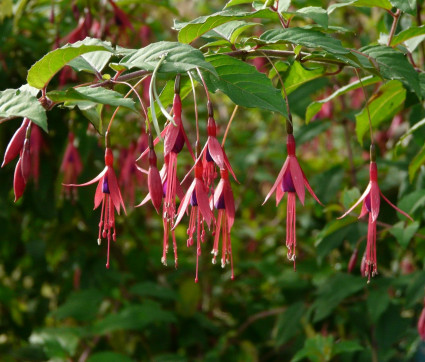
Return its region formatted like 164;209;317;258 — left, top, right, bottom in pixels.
211;169;235;280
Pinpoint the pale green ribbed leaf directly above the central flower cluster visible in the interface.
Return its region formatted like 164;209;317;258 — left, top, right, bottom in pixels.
120;41;216;74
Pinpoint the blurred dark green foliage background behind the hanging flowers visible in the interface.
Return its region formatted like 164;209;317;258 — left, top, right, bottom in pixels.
0;0;425;362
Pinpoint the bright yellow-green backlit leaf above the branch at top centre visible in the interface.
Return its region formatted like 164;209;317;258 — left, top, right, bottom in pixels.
174;9;277;44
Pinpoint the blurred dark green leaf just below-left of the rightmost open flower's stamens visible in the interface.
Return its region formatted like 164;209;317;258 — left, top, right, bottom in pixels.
312;273;366;322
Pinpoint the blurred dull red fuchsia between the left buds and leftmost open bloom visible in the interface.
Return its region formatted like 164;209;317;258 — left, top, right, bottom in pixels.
60;132;83;199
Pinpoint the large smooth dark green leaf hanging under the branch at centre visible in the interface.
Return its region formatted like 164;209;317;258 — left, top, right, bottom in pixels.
201;55;286;116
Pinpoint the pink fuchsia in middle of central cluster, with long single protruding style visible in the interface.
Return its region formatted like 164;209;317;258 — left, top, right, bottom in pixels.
173;161;214;283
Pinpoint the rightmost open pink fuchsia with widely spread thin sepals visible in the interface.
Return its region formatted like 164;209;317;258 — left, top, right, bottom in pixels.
338;160;413;282
